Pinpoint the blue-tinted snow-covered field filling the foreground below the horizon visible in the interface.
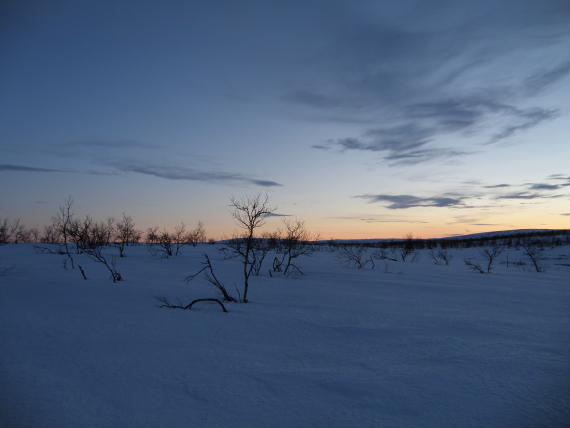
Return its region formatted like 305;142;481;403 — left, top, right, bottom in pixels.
0;244;570;428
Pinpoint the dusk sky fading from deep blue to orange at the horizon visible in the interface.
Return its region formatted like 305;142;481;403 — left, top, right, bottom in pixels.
0;0;570;239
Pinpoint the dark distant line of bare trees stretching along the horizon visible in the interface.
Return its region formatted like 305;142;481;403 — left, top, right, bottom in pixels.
0;198;570;252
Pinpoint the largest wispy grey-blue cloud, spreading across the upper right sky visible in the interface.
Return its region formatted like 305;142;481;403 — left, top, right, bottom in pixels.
292;2;570;165
